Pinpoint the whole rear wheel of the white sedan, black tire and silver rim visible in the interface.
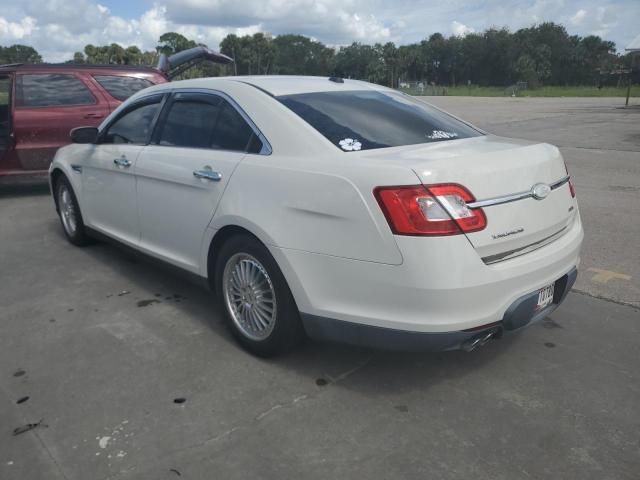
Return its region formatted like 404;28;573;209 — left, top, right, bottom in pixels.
215;235;304;357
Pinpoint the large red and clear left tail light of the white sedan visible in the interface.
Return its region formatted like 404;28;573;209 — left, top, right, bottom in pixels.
373;183;487;236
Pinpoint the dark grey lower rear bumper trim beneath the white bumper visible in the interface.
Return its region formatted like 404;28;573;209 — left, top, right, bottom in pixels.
301;268;578;351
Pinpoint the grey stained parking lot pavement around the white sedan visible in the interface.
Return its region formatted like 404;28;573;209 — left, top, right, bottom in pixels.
0;98;640;480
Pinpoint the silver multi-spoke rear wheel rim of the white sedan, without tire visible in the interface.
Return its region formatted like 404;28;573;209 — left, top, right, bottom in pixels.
222;253;277;341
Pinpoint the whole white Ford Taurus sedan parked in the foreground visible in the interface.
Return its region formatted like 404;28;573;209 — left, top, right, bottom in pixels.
50;76;583;355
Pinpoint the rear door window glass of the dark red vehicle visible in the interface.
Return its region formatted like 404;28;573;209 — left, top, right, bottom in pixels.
16;73;96;107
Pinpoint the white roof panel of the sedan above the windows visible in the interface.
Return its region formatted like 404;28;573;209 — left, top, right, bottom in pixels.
152;75;387;96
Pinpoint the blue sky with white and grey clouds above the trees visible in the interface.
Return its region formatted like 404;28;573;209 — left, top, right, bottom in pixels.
0;0;640;62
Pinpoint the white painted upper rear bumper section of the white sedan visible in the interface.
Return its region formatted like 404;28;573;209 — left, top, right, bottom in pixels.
270;212;583;333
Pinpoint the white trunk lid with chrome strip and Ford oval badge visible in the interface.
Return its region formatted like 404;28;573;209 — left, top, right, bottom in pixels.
362;135;577;264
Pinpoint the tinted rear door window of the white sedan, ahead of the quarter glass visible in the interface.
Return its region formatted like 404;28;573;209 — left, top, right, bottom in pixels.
158;93;222;148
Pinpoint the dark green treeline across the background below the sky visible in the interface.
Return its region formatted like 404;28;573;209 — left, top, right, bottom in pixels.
53;22;628;87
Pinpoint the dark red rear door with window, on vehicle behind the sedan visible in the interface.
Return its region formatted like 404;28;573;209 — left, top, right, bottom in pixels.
13;71;109;170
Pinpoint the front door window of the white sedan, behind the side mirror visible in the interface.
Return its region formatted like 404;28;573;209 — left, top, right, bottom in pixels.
100;96;162;145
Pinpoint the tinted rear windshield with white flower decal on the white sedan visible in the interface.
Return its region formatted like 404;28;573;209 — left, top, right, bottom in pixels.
276;91;482;152
